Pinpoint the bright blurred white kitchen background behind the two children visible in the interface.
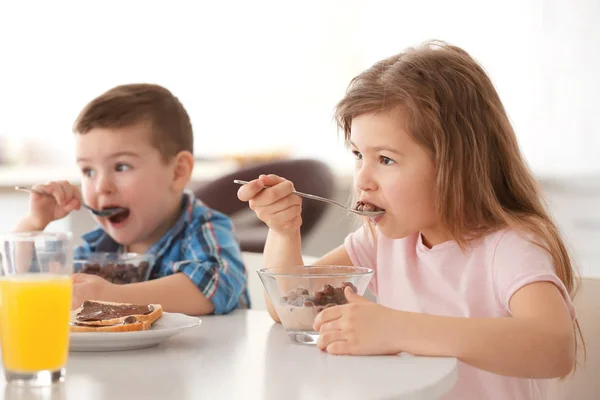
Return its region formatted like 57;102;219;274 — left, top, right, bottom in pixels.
0;0;600;276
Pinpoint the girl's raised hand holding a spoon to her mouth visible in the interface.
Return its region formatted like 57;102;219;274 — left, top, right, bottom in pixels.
238;175;302;235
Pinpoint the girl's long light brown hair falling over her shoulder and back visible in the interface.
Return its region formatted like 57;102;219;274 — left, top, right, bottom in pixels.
336;41;585;368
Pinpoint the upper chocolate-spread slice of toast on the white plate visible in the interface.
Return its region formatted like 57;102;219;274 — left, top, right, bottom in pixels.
71;300;163;328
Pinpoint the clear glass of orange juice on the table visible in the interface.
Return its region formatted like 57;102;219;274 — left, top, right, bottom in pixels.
0;232;73;386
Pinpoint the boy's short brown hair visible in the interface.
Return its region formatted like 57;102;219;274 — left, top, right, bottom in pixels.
73;83;194;160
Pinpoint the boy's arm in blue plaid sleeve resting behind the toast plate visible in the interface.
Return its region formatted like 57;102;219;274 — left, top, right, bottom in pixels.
73;213;247;315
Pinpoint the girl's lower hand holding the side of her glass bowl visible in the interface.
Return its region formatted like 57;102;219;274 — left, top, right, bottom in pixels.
313;287;404;355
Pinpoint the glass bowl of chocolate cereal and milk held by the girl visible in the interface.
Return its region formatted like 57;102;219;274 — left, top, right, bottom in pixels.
257;266;373;344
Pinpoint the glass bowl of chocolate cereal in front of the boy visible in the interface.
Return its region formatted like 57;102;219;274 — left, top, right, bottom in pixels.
73;252;154;284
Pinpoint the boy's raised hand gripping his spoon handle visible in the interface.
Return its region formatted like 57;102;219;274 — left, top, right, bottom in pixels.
26;181;81;230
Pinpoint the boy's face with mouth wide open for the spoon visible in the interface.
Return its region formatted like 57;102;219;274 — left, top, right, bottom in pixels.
75;123;181;251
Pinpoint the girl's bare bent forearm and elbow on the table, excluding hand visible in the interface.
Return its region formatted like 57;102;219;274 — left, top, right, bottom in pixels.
393;282;576;378
